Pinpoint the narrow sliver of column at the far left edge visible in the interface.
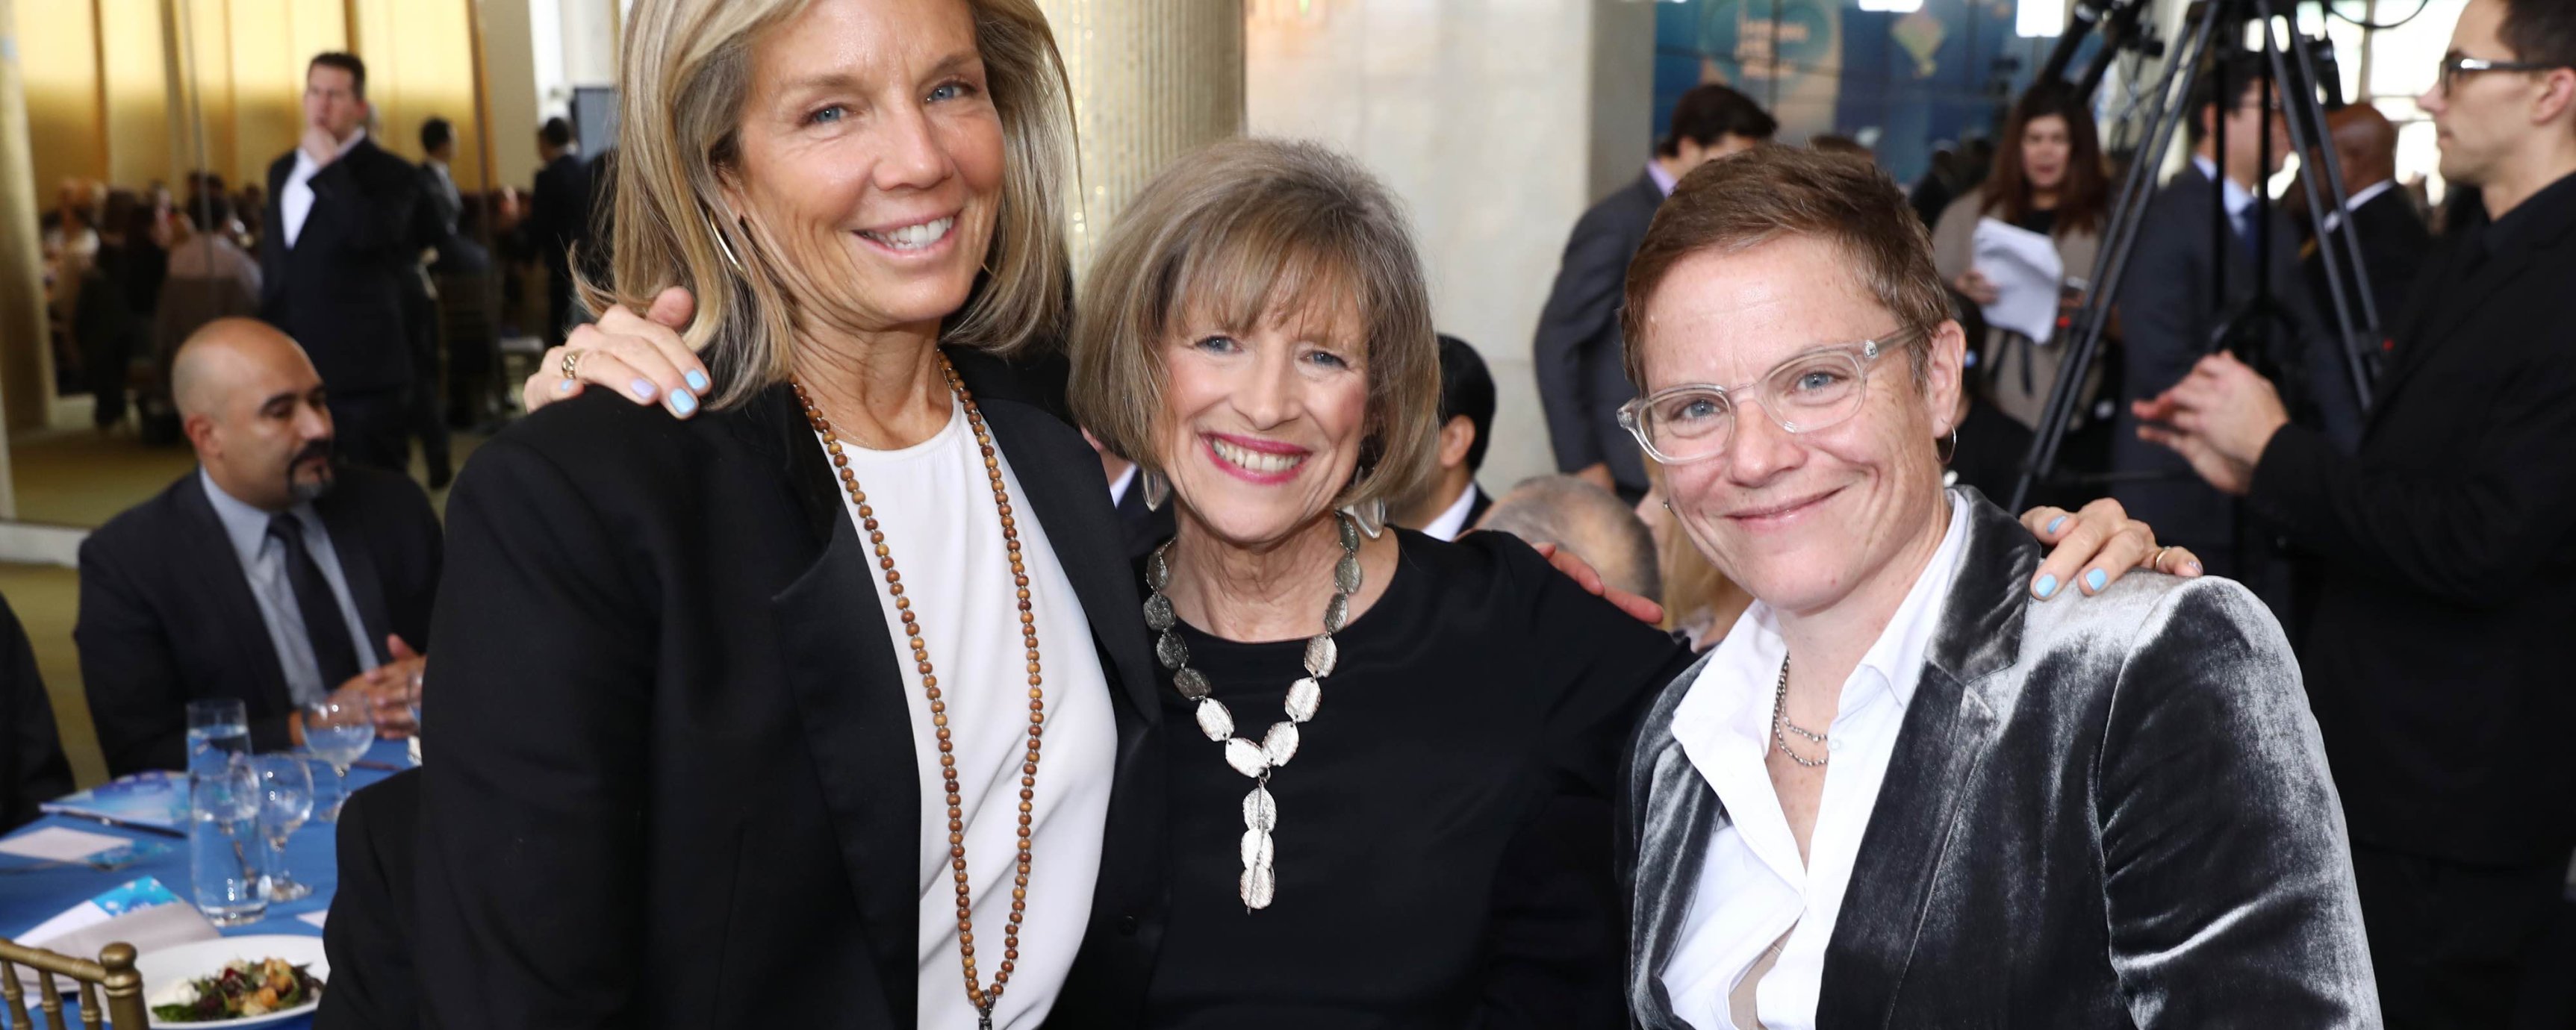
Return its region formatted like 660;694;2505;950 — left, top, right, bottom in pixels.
0;0;54;466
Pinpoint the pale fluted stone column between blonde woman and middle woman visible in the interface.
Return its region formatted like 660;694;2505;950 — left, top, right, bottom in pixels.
1038;0;1244;270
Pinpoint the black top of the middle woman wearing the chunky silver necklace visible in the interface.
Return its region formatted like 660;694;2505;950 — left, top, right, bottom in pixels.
1146;531;1690;1028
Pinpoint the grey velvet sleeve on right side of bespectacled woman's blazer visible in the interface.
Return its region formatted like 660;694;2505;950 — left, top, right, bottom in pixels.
2094;579;2380;1028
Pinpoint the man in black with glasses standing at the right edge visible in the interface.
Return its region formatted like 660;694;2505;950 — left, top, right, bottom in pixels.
2138;0;2576;1028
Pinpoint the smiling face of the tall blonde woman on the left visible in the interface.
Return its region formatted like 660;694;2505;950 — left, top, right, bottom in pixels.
727;0;1005;332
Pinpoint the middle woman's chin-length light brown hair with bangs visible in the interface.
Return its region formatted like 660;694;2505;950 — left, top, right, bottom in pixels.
1071;139;1440;505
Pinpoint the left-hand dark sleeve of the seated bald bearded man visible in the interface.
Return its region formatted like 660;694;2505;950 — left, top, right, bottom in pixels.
72;533;196;775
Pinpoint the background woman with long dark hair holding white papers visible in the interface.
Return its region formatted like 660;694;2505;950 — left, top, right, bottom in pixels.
1932;85;2112;499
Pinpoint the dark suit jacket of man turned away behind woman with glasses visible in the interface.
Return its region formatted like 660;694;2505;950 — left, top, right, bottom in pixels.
1530;175;1664;494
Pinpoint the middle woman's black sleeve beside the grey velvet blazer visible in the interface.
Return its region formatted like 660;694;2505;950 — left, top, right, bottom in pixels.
1460;533;1693;1028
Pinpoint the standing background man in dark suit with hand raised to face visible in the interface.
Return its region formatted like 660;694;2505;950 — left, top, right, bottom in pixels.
260;52;420;471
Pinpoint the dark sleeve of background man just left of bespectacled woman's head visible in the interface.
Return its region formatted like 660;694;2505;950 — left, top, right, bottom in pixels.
1530;208;1633;471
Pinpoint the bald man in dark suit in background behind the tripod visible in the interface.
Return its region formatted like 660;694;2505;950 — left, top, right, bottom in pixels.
2306;103;2432;327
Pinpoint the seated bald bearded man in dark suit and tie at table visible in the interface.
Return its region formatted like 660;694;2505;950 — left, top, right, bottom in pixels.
72;319;441;775
